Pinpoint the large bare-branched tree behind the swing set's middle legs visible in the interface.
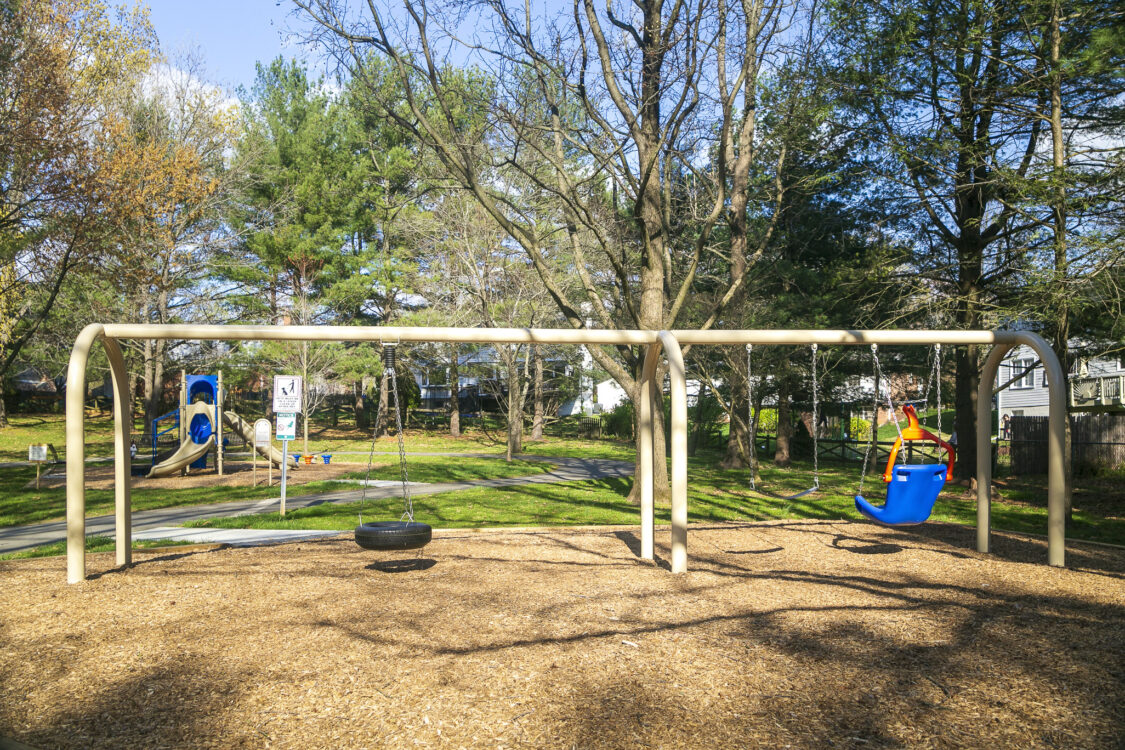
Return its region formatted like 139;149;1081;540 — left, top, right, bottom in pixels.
296;0;828;501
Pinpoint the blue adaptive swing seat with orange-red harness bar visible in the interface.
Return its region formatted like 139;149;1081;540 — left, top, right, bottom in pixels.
855;405;954;526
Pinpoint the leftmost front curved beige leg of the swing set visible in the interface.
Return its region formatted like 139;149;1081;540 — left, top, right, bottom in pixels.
66;323;105;584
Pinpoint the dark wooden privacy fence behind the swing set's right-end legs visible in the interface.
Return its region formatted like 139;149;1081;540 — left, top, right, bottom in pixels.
1011;414;1125;475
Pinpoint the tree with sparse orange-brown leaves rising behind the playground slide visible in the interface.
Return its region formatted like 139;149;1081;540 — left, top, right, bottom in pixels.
98;61;237;424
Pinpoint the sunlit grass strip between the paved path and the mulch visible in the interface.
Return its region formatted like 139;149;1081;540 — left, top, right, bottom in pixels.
191;457;1125;544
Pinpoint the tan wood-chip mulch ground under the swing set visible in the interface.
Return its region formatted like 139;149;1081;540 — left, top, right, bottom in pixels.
0;521;1125;748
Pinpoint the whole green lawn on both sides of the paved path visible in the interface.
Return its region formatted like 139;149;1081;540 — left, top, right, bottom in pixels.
0;415;1125;544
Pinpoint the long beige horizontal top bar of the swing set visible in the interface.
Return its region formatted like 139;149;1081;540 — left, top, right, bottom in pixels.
104;323;1025;345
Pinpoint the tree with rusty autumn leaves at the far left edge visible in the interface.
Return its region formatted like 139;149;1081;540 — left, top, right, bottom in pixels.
0;0;155;426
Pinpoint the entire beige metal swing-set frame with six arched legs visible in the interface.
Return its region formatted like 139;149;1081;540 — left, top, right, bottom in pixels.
66;324;1070;584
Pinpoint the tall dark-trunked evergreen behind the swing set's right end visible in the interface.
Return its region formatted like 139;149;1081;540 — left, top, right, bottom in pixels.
835;0;1062;478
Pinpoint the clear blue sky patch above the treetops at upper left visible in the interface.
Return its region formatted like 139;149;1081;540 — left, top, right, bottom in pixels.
146;0;315;89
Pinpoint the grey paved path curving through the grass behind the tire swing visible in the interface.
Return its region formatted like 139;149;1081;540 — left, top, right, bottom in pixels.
0;453;633;554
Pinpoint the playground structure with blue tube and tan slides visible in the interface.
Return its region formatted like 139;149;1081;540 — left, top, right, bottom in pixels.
146;370;285;479
